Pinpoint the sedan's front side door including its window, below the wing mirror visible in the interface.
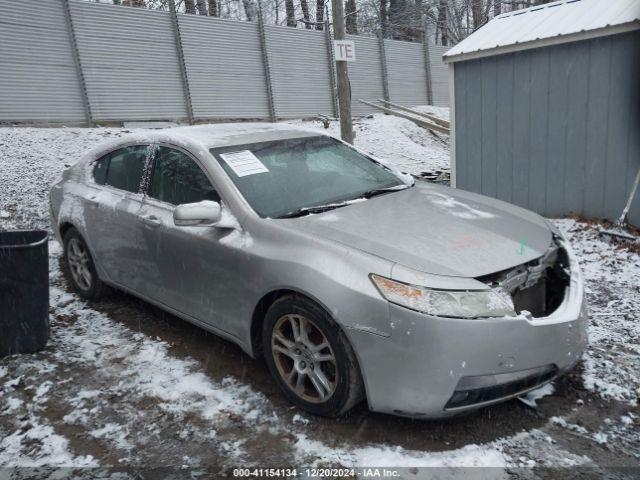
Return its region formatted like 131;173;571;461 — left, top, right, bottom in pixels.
140;145;240;330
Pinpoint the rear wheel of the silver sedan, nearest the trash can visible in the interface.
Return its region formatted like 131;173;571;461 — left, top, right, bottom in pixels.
63;228;108;300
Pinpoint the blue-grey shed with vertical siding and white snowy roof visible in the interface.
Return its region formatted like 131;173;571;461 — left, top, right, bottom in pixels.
445;0;640;225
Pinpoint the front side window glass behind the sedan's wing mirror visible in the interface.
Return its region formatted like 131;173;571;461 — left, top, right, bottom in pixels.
149;147;220;205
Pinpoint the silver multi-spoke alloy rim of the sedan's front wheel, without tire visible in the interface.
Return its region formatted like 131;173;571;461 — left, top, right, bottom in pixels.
271;314;338;403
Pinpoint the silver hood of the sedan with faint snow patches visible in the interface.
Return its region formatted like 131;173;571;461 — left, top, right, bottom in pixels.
287;182;552;277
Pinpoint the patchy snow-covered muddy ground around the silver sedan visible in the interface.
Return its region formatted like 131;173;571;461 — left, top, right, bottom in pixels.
0;111;640;478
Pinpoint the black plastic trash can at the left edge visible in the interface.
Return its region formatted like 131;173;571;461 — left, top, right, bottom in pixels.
0;230;49;357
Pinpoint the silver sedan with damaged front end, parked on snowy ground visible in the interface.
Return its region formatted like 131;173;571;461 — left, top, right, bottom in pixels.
50;124;587;418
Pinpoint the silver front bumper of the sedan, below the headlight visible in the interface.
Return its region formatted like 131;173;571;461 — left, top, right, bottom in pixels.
349;239;588;418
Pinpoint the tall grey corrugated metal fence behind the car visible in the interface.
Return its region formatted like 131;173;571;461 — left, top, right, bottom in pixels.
0;0;448;124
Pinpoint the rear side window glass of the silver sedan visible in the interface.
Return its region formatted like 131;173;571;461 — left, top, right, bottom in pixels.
99;145;149;193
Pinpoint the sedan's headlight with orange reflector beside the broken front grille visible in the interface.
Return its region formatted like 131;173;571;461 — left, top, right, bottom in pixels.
371;274;516;318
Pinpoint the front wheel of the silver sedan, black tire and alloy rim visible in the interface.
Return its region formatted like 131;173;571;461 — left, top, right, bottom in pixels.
262;295;364;417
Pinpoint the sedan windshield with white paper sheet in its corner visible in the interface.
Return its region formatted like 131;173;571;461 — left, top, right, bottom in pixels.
211;136;406;218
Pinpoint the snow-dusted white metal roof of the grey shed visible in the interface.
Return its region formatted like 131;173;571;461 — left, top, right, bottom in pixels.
443;0;640;62
